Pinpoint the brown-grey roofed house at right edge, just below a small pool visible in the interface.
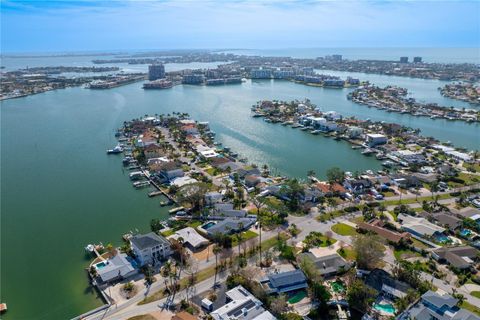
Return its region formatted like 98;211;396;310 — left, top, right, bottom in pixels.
431;246;480;270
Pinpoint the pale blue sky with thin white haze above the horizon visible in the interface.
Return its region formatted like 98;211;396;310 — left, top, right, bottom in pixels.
0;0;480;53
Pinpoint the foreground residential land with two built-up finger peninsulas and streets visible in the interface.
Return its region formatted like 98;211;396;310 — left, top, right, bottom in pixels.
82;100;480;320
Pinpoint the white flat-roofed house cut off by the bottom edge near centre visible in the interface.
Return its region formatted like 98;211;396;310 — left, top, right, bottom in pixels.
210;286;276;320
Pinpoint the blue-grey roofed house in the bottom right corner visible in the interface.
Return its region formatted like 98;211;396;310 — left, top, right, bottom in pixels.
399;290;480;320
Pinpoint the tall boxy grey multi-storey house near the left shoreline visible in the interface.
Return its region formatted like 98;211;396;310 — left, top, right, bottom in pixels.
130;232;171;266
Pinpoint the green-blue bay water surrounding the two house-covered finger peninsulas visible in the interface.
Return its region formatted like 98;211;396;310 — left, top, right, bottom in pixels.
0;53;480;319
